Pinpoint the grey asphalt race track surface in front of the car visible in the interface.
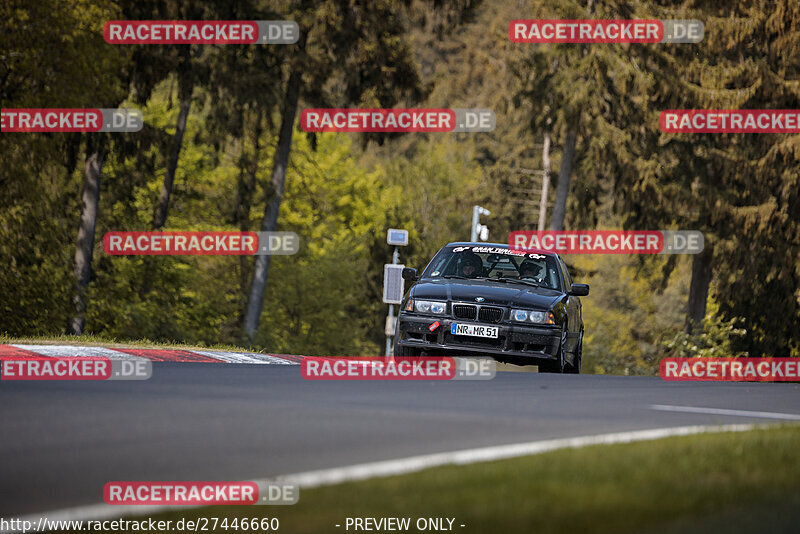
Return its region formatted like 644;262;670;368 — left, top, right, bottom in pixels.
0;362;800;517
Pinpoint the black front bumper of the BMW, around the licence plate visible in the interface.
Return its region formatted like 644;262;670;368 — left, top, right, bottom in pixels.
396;312;561;360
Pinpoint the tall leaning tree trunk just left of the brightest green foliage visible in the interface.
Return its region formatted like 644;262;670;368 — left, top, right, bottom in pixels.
244;68;300;341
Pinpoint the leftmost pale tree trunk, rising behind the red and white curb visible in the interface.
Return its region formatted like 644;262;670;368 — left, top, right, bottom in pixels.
67;137;105;335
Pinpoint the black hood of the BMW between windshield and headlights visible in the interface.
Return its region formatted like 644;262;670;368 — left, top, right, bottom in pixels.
410;279;564;309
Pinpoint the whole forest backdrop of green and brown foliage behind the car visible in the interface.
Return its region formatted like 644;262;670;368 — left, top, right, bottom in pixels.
0;0;800;368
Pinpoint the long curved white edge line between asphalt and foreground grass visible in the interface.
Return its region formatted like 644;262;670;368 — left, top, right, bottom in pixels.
4;424;762;532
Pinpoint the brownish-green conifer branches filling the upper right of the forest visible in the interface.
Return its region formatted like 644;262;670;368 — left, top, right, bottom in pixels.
509;0;800;362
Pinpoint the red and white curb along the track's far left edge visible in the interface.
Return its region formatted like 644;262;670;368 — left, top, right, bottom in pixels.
0;344;303;365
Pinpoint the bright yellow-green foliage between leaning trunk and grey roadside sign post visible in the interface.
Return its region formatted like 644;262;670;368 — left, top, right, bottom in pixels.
257;134;394;355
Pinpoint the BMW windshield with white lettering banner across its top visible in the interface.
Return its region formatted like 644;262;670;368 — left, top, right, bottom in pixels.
422;246;561;291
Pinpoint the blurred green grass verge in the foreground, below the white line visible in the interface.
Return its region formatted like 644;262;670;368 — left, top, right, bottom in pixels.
54;426;800;534
